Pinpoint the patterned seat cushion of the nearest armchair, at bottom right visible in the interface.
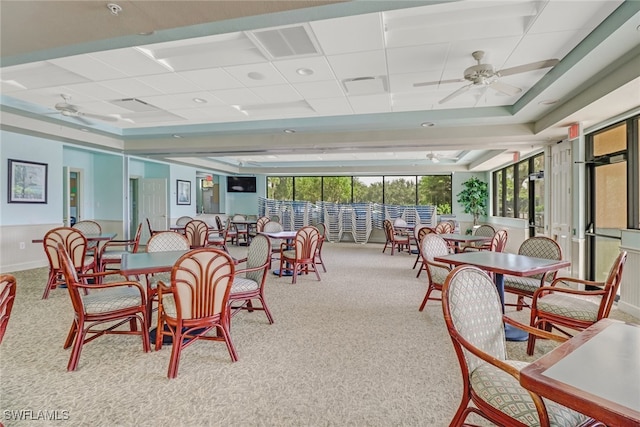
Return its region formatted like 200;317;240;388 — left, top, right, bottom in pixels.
470;360;587;427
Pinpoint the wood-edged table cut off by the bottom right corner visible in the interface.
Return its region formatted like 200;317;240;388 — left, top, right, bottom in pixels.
520;319;640;427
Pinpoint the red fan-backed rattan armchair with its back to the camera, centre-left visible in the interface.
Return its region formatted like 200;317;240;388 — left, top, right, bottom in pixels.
155;248;238;378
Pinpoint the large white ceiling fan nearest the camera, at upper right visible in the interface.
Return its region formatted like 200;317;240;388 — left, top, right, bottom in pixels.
413;50;559;104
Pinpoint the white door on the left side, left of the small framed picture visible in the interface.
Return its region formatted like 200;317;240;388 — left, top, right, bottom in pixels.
138;179;168;242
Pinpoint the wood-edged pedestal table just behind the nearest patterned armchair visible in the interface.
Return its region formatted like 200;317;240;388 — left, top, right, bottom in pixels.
434;251;571;341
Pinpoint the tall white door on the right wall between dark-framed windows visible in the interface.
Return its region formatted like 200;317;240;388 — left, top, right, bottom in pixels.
550;141;573;274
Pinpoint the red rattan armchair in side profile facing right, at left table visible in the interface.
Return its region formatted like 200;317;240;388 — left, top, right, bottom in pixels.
56;243;150;371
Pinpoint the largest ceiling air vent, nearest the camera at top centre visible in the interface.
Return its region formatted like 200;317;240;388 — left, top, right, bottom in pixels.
248;25;320;59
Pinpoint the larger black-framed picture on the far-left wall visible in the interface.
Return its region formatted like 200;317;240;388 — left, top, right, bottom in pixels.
8;159;48;203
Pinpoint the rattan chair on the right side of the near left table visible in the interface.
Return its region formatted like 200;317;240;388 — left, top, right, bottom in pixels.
229;234;273;323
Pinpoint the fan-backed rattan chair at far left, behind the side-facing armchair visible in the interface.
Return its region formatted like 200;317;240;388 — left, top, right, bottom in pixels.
42;227;97;299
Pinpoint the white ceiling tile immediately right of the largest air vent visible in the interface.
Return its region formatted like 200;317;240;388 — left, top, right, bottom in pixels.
310;13;384;55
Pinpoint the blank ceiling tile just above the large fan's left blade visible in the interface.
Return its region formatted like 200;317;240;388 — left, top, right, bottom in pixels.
387;43;449;74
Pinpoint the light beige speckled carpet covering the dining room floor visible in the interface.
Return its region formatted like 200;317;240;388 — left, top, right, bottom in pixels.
0;243;636;427
